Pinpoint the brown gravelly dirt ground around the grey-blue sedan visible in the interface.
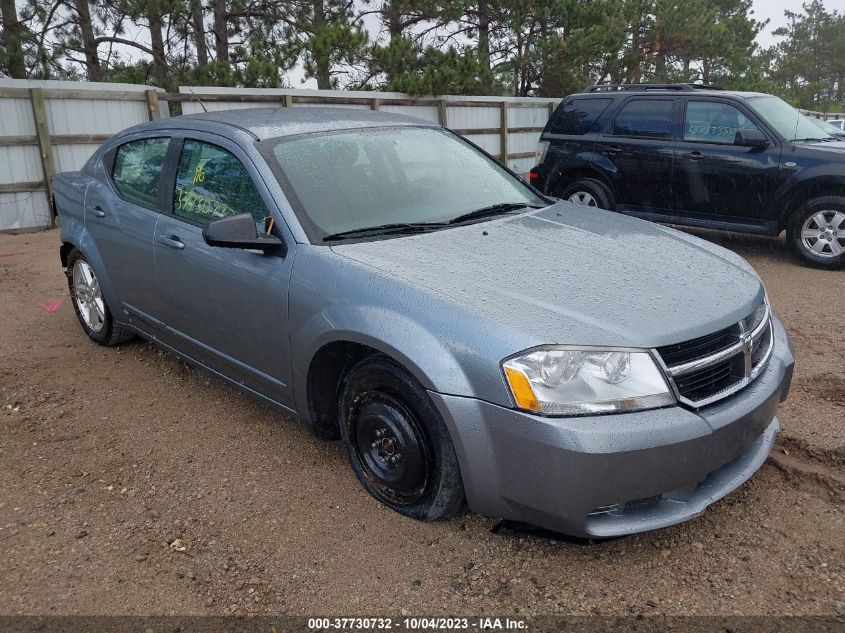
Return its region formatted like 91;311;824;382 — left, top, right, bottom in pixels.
0;231;845;617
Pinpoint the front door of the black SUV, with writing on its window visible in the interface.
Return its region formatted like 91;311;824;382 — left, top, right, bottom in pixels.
673;97;780;225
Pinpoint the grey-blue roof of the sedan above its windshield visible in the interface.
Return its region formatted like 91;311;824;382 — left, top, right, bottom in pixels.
138;106;437;140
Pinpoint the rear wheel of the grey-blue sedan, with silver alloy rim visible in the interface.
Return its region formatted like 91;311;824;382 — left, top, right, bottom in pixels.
66;248;135;346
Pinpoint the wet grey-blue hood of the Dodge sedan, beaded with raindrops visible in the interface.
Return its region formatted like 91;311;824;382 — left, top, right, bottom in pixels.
332;202;764;347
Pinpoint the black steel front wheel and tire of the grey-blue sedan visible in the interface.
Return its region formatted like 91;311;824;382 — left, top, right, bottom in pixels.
339;355;464;521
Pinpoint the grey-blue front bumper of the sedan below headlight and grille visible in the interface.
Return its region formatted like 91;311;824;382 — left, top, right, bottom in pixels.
431;318;794;538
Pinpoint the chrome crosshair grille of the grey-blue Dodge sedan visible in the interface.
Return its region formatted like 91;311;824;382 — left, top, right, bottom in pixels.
657;301;773;408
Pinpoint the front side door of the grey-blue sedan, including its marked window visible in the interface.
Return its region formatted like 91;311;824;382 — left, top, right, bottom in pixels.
154;134;295;406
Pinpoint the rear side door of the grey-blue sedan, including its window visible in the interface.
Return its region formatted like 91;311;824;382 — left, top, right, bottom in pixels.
85;134;170;318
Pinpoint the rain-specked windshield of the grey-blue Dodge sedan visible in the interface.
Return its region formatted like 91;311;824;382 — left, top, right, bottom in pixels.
267;127;542;242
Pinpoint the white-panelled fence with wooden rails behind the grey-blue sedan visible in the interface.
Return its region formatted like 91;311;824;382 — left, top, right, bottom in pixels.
0;80;559;232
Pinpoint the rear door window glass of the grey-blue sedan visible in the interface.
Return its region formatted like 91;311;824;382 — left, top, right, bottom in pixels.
112;138;170;211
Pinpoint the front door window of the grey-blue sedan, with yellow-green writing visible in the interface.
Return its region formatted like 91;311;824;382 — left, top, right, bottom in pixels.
173;139;269;231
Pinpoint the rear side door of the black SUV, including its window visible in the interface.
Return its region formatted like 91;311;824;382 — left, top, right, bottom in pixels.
596;96;676;213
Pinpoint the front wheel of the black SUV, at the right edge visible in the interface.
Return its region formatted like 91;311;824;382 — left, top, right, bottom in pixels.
786;196;845;268
